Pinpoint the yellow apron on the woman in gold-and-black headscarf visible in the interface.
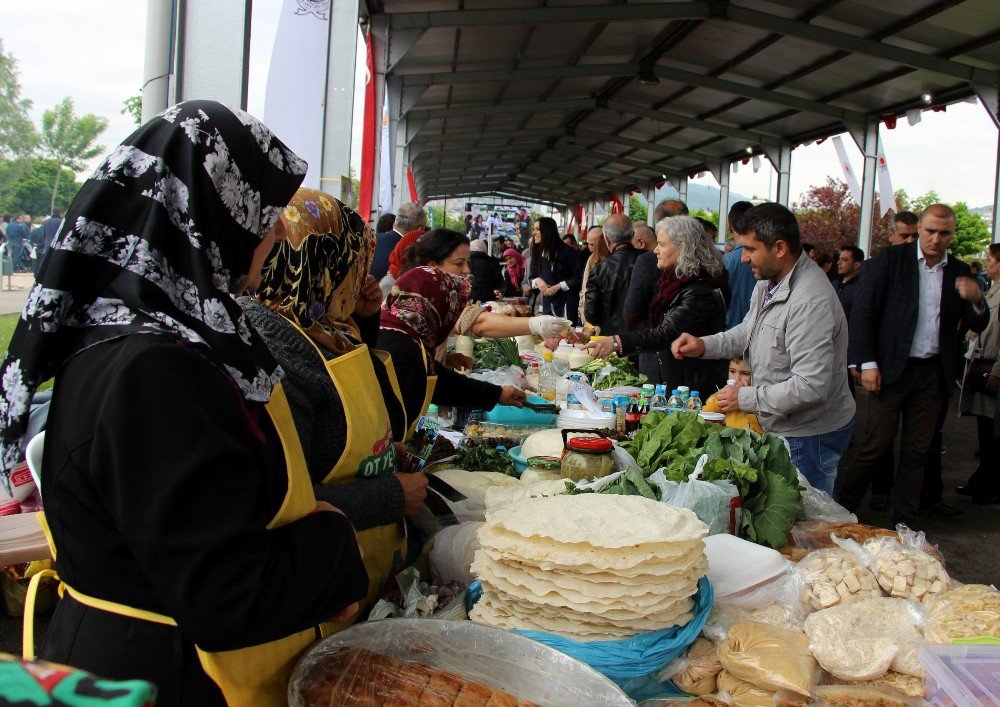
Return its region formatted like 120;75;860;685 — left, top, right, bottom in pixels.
274;318;406;636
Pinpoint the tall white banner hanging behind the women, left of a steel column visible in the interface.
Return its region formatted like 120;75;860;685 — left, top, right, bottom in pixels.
264;0;330;190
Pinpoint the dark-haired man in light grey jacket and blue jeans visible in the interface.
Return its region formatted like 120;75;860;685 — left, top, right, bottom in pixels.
671;204;855;493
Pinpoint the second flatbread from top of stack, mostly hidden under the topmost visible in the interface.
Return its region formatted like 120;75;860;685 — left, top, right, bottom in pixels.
479;524;705;574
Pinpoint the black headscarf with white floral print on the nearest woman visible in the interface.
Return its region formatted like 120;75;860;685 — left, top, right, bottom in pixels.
0;101;306;490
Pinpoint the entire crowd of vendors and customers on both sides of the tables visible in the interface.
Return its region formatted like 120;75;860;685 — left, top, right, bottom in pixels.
0;101;1000;705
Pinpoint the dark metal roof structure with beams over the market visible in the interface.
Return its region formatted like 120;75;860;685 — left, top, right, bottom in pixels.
370;0;1000;242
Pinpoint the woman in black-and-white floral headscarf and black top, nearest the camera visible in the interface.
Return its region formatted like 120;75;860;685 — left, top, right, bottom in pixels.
0;101;367;705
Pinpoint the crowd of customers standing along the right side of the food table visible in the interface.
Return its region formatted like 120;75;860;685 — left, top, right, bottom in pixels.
424;191;1000;527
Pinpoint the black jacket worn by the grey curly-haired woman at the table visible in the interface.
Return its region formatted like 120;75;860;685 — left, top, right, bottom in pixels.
616;280;729;401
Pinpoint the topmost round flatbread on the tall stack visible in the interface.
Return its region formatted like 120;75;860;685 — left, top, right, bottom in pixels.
486;494;708;549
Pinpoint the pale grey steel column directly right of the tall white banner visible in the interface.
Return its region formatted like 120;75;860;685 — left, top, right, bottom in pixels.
319;0;360;194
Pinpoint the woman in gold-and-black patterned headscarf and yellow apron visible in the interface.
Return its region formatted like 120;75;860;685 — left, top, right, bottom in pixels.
245;189;427;620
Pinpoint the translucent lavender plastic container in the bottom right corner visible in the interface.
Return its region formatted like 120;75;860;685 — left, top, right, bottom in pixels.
919;643;1000;707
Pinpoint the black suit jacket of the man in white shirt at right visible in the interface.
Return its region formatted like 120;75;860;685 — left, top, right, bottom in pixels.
848;243;989;385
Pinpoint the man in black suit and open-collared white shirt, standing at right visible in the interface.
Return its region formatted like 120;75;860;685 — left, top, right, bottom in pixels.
839;204;989;525
